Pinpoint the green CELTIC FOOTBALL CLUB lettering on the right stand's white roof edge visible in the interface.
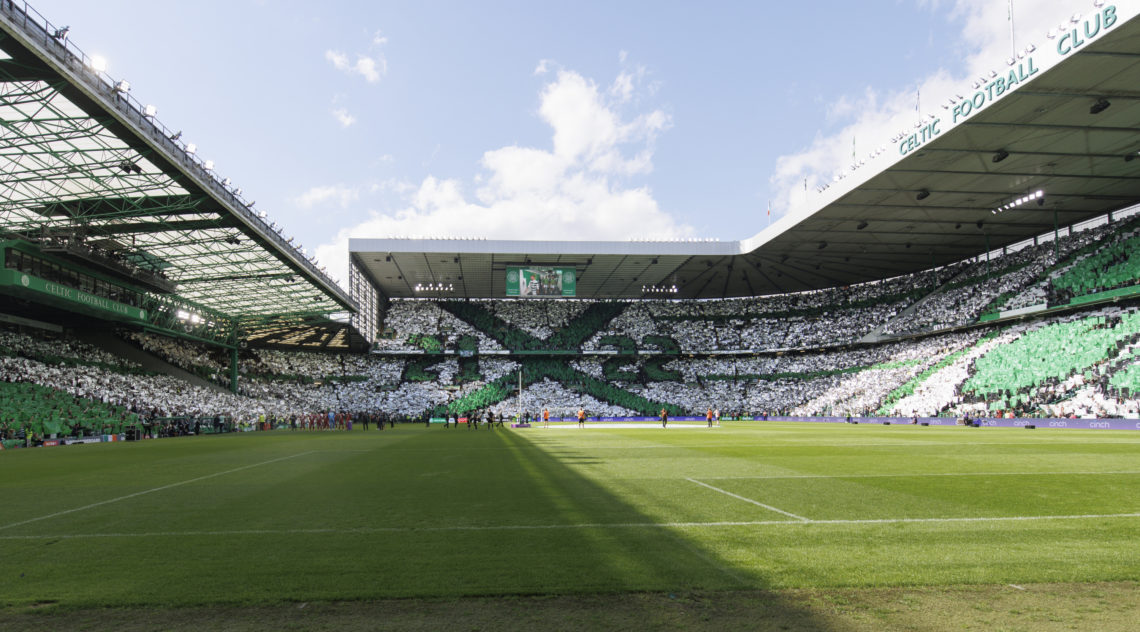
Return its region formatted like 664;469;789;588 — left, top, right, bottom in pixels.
896;5;1118;156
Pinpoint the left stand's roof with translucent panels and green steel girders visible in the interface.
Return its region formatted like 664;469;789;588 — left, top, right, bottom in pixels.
0;2;357;332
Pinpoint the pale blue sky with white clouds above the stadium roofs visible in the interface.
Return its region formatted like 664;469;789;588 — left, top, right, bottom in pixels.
32;0;1093;278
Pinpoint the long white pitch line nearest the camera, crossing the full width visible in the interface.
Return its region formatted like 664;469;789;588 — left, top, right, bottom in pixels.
0;513;1140;541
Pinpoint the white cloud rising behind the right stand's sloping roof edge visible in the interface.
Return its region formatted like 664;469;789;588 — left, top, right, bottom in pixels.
771;0;1091;219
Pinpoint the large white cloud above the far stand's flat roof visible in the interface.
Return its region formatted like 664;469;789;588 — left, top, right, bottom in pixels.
315;61;694;278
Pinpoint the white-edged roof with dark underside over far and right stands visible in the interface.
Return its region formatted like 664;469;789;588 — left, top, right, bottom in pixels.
349;6;1140;298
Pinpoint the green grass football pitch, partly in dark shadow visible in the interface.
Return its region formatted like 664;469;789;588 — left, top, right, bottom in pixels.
0;422;1140;625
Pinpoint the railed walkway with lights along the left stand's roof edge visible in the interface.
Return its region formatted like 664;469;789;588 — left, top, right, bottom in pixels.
0;0;355;306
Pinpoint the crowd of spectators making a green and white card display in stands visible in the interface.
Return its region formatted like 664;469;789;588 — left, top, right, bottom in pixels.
0;208;1140;440
